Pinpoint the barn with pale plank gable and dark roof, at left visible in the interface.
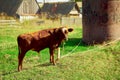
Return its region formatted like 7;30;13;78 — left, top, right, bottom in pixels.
0;0;40;21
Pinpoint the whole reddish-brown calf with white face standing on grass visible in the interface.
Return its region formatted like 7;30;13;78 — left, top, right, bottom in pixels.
17;27;73;71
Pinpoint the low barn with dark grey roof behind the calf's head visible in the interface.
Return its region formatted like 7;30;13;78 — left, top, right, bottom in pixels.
41;2;80;16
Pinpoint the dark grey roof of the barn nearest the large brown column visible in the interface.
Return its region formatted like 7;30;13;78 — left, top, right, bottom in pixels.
41;2;79;15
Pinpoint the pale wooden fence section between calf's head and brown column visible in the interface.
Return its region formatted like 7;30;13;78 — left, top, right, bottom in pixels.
60;17;82;25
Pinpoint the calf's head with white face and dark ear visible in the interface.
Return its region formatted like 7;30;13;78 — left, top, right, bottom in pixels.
56;27;73;40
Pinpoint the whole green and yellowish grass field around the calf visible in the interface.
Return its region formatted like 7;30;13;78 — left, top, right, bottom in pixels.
0;21;120;80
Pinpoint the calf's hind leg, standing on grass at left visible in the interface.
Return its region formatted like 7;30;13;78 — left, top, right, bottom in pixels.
18;50;27;71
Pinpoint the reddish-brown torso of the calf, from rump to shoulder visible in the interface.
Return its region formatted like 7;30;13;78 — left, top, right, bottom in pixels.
18;29;54;52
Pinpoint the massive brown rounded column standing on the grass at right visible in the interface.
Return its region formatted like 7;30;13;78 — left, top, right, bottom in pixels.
83;0;120;44
